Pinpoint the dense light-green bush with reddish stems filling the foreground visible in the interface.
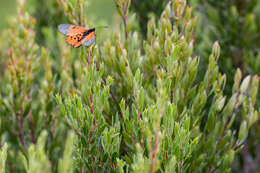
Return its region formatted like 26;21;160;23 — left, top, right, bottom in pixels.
0;0;259;172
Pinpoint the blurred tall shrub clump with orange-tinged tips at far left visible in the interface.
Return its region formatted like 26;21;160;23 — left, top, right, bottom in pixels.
0;1;68;172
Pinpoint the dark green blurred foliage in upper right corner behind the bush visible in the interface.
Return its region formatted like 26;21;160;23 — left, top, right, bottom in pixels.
195;0;260;75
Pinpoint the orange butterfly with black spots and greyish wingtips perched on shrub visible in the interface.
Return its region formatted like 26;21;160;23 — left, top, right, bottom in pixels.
58;24;96;48
